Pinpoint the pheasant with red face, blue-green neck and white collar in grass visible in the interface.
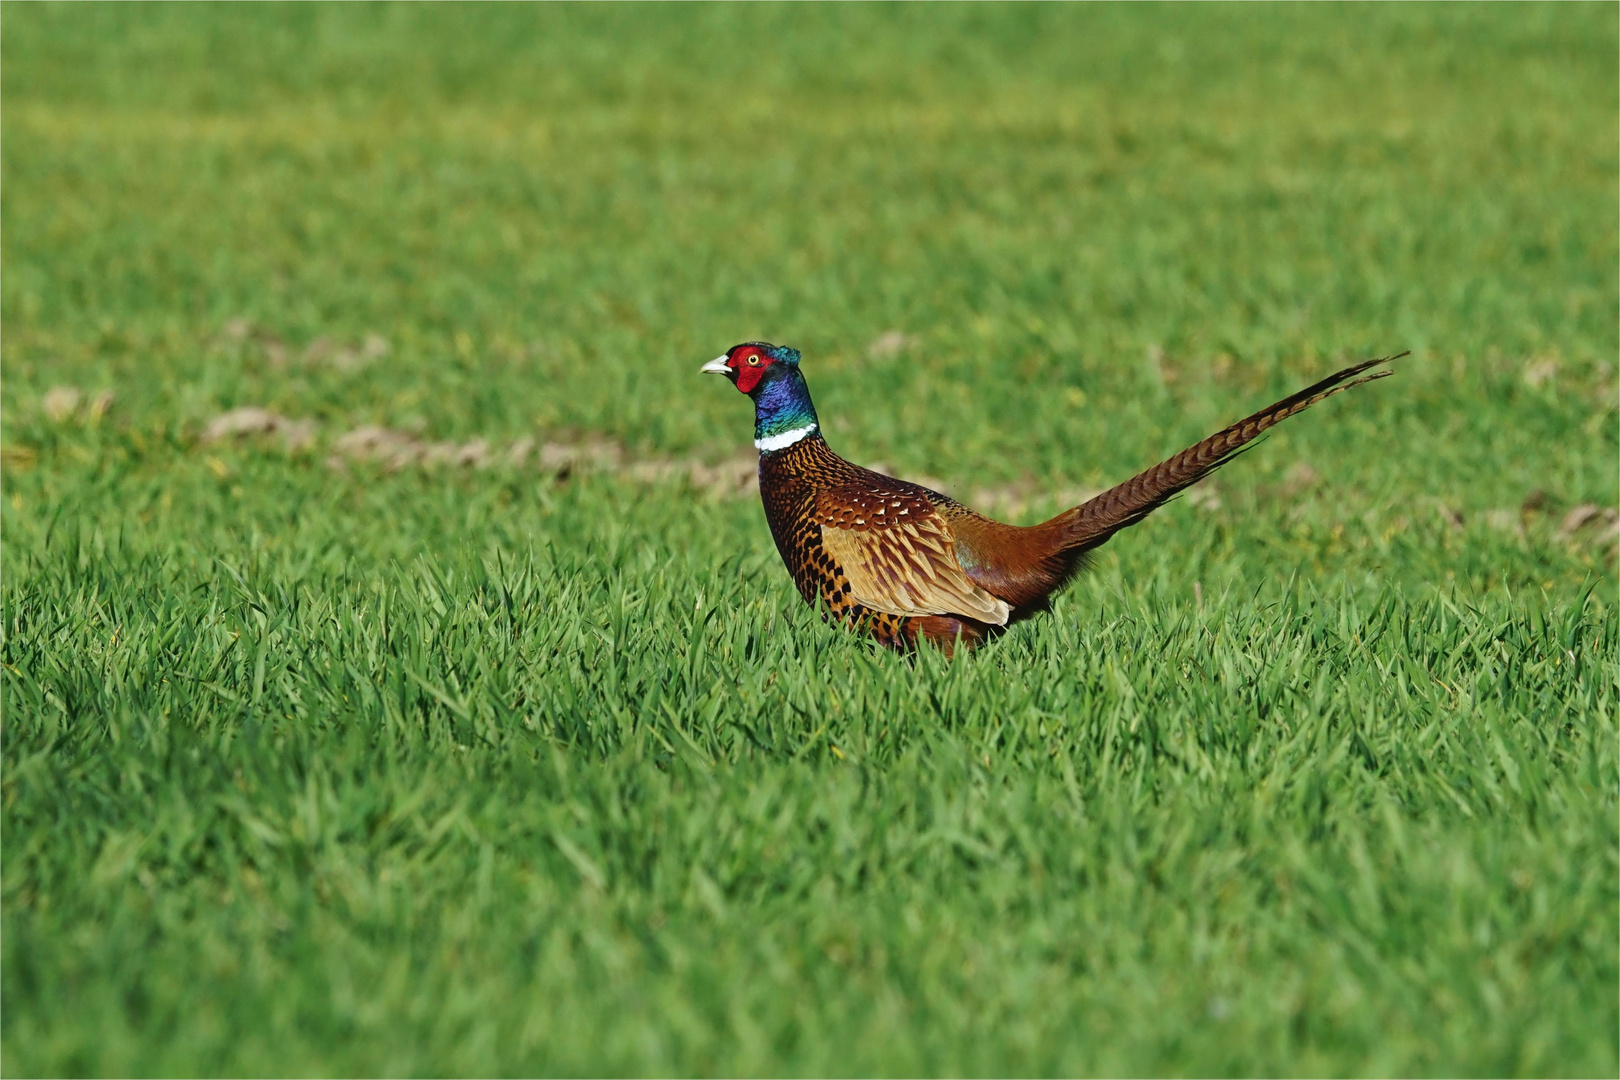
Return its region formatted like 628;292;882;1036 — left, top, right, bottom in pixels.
701;342;1406;653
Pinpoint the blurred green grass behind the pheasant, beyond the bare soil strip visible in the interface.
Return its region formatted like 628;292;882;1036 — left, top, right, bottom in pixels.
3;6;1615;504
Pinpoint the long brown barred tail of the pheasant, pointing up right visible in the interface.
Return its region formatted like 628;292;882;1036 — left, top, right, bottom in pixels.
1048;353;1408;554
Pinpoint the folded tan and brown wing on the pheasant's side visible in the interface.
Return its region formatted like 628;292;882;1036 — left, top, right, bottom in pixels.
816;484;1011;627
